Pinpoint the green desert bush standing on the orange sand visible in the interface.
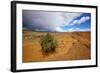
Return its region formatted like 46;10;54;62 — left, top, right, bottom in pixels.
40;33;57;54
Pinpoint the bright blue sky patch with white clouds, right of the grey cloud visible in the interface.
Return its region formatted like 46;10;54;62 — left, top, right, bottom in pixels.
62;13;91;31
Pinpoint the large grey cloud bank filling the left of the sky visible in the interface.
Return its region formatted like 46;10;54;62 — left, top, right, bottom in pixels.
23;10;82;31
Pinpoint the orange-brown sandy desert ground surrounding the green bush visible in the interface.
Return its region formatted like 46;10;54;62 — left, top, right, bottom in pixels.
22;31;91;63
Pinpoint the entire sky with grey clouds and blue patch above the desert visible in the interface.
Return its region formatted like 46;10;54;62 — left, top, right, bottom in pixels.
22;10;91;32
